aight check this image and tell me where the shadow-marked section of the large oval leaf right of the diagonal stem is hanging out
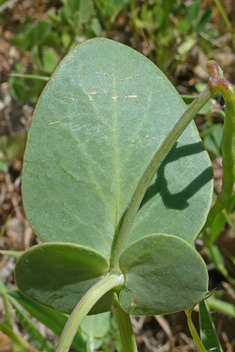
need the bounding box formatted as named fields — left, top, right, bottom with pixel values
left=127, top=140, right=213, bottom=244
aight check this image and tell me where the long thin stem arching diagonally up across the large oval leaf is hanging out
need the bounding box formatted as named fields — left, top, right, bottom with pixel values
left=110, top=86, right=213, bottom=272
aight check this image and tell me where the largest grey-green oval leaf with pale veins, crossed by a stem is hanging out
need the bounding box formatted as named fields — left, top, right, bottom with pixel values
left=23, top=39, right=212, bottom=258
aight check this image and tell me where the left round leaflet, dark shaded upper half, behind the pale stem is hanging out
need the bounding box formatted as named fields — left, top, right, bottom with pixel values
left=15, top=243, right=112, bottom=313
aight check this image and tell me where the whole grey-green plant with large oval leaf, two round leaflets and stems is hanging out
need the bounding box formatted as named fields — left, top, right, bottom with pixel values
left=16, top=39, right=235, bottom=352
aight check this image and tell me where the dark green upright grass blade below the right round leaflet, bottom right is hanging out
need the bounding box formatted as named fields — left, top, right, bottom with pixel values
left=199, top=301, right=223, bottom=352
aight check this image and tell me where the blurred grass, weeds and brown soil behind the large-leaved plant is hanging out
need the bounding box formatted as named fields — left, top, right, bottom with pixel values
left=0, top=0, right=235, bottom=352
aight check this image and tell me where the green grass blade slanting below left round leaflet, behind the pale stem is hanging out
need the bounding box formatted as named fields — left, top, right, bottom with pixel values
left=7, top=290, right=85, bottom=351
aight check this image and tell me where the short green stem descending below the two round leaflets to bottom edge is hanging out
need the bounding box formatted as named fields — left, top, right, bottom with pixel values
left=115, top=306, right=138, bottom=352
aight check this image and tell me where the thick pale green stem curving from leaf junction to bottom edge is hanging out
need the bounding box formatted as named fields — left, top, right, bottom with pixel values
left=55, top=275, right=124, bottom=352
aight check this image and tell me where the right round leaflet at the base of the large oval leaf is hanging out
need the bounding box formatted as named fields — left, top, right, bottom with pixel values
left=119, top=234, right=208, bottom=315
